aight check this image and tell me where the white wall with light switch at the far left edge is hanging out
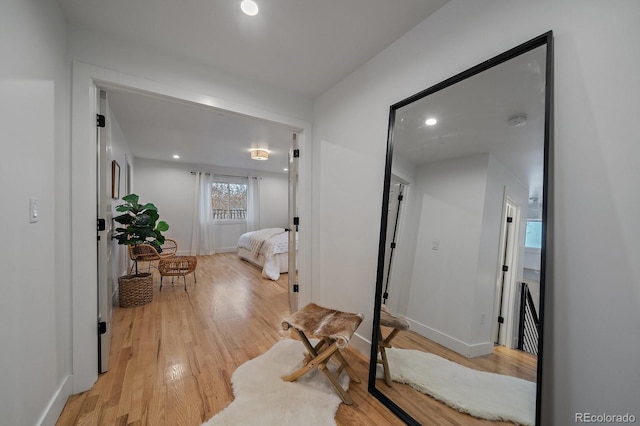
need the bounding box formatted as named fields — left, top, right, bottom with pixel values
left=0, top=0, right=71, bottom=425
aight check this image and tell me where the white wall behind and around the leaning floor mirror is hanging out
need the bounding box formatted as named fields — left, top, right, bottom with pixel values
left=313, top=0, right=640, bottom=425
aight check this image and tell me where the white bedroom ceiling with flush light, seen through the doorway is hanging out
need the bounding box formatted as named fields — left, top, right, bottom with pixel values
left=107, top=89, right=293, bottom=173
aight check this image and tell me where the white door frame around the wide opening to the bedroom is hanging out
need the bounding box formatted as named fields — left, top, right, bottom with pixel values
left=69, top=61, right=312, bottom=394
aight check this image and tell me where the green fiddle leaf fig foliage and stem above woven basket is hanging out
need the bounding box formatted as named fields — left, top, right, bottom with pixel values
left=113, top=194, right=169, bottom=275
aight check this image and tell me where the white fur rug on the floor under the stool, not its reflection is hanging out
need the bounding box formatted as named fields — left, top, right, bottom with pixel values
left=203, top=339, right=349, bottom=426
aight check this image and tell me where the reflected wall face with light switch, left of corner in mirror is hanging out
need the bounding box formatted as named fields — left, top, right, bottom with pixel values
left=400, top=155, right=489, bottom=356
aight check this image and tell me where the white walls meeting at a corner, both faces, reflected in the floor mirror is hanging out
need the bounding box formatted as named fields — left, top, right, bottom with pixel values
left=389, top=154, right=528, bottom=357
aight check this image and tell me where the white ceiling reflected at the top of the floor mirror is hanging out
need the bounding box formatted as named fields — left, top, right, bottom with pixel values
left=394, top=46, right=546, bottom=205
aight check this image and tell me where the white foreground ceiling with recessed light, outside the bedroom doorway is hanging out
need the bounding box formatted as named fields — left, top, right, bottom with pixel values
left=58, top=0, right=447, bottom=98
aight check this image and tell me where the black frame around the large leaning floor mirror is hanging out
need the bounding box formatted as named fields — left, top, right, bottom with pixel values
left=368, top=31, right=553, bottom=426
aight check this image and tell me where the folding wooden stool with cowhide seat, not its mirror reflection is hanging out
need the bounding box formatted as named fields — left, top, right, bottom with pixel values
left=282, top=303, right=364, bottom=405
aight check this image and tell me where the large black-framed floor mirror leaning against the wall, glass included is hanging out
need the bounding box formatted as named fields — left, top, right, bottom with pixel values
left=369, top=32, right=553, bottom=425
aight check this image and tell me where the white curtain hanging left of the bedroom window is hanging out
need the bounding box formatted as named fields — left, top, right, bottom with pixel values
left=191, top=172, right=215, bottom=256
